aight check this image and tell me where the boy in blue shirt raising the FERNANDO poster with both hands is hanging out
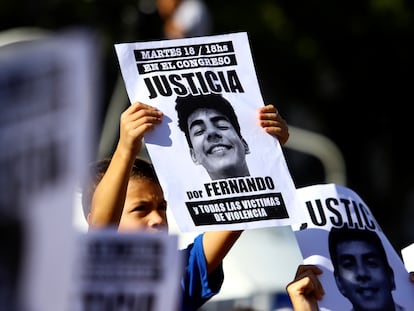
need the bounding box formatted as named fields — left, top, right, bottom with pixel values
left=82, top=103, right=289, bottom=310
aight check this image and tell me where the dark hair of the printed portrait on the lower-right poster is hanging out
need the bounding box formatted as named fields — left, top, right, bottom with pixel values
left=328, top=226, right=392, bottom=271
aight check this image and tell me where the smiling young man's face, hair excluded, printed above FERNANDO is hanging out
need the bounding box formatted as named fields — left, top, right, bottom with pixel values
left=187, top=108, right=249, bottom=179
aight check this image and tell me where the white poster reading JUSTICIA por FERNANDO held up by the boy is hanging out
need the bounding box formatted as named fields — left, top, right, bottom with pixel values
left=115, top=32, right=302, bottom=232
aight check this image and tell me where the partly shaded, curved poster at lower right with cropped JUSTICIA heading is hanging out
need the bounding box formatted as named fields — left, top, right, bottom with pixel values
left=292, top=184, right=414, bottom=311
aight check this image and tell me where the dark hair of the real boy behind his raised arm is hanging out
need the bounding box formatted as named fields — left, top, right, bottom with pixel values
left=82, top=157, right=159, bottom=219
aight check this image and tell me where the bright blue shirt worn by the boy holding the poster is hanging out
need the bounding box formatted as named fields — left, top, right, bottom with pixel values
left=180, top=234, right=224, bottom=311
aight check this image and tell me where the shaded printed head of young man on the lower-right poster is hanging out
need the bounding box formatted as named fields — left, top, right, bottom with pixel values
left=329, top=228, right=399, bottom=311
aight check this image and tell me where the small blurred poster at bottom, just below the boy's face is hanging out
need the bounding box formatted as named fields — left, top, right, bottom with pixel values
left=69, top=229, right=183, bottom=311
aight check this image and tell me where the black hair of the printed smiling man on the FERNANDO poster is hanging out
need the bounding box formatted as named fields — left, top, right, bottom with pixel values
left=175, top=93, right=243, bottom=148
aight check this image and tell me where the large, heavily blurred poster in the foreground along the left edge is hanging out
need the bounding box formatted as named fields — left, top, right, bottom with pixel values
left=0, top=30, right=97, bottom=311
